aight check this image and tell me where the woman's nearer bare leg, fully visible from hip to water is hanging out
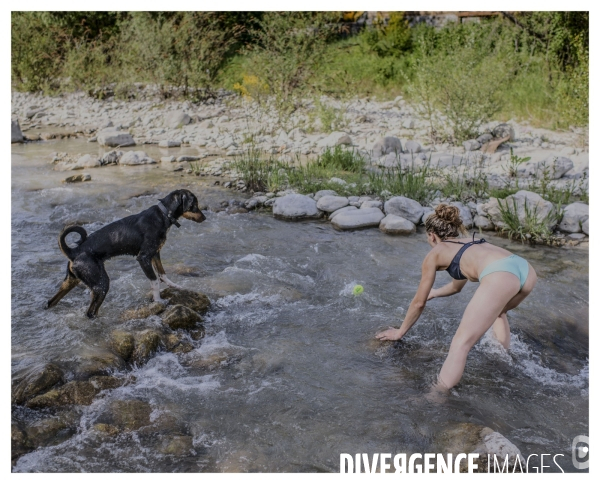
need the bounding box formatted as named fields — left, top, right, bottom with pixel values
left=438, top=272, right=520, bottom=389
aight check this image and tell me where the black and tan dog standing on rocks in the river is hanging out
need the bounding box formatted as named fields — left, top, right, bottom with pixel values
left=46, top=190, right=206, bottom=318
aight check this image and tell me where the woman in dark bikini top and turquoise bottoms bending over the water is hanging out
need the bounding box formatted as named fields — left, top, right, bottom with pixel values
left=376, top=204, right=537, bottom=390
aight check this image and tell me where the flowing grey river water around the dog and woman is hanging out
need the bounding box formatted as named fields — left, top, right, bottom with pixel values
left=11, top=140, right=588, bottom=472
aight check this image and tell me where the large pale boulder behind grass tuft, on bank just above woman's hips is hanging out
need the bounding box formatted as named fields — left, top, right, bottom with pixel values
left=481, top=190, right=557, bottom=230
